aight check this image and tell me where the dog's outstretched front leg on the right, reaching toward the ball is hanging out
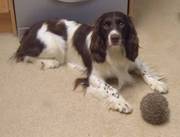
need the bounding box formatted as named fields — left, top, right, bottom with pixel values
left=135, top=59, right=168, bottom=93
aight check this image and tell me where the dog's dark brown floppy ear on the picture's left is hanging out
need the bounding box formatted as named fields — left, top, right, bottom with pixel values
left=90, top=16, right=106, bottom=63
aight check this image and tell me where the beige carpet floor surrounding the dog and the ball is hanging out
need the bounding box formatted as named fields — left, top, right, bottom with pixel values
left=0, top=0, right=180, bottom=137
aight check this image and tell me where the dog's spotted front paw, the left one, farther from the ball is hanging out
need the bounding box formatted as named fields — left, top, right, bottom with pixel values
left=110, top=96, right=133, bottom=114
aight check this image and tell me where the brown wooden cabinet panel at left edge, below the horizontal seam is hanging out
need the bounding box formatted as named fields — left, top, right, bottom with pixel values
left=0, top=13, right=12, bottom=32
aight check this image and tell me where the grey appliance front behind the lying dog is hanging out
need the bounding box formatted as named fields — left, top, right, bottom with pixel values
left=14, top=0, right=128, bottom=34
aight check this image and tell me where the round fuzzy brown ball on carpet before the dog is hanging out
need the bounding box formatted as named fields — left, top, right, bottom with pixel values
left=140, top=92, right=169, bottom=125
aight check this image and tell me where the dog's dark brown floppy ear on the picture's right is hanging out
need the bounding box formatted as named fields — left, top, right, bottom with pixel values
left=125, top=17, right=139, bottom=61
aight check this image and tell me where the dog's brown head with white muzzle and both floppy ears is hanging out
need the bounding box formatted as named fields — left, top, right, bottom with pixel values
left=90, top=12, right=139, bottom=63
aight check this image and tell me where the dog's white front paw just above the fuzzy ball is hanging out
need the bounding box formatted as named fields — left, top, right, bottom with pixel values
left=151, top=80, right=168, bottom=94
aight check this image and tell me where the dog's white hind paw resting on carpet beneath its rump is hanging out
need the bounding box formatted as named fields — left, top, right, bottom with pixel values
left=41, top=60, right=60, bottom=70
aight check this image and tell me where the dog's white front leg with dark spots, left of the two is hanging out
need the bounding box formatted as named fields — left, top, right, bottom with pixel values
left=87, top=75, right=132, bottom=114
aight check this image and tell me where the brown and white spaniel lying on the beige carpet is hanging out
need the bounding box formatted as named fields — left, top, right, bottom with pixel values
left=15, top=12, right=168, bottom=113
